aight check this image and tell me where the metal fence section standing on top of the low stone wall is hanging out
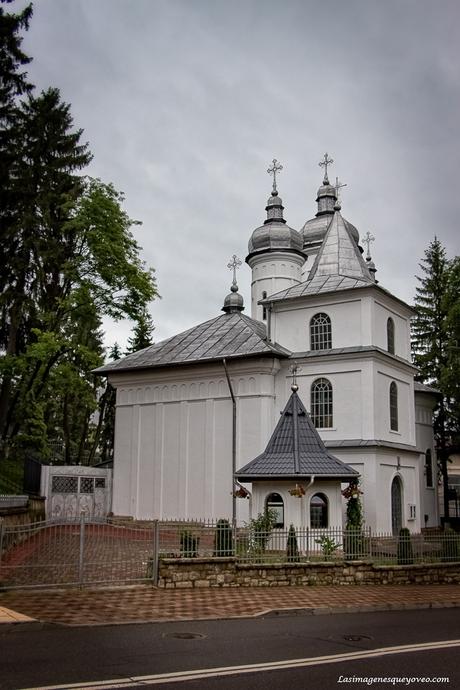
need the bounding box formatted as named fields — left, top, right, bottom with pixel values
left=158, top=521, right=460, bottom=565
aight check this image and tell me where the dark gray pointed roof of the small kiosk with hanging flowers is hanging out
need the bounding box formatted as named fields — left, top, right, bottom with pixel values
left=236, top=392, right=358, bottom=481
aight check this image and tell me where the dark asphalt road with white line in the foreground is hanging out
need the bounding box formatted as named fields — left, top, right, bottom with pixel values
left=0, top=609, right=460, bottom=690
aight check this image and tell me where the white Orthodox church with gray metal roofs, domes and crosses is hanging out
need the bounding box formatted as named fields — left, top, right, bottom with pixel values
left=96, top=154, right=439, bottom=533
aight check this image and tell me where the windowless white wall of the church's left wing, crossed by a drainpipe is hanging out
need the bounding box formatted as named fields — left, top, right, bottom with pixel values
left=111, top=358, right=278, bottom=520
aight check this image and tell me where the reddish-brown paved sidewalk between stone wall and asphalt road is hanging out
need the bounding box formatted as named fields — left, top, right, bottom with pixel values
left=0, top=585, right=460, bottom=625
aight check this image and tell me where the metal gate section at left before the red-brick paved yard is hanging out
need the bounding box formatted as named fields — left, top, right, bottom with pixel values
left=0, top=515, right=157, bottom=588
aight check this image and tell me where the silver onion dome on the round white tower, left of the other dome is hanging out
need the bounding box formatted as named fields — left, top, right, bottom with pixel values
left=246, top=190, right=303, bottom=261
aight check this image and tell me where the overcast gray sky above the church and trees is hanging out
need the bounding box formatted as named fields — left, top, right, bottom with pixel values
left=20, top=0, right=460, bottom=352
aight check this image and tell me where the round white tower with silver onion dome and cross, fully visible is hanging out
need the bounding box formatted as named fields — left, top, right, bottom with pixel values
left=246, top=158, right=305, bottom=323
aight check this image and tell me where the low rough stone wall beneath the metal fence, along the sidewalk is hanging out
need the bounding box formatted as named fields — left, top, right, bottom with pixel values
left=158, top=558, right=460, bottom=589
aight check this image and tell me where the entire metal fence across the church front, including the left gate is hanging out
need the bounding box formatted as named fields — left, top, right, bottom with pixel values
left=0, top=516, right=460, bottom=589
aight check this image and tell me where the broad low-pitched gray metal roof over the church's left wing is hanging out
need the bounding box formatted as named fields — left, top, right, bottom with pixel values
left=95, top=312, right=290, bottom=374
